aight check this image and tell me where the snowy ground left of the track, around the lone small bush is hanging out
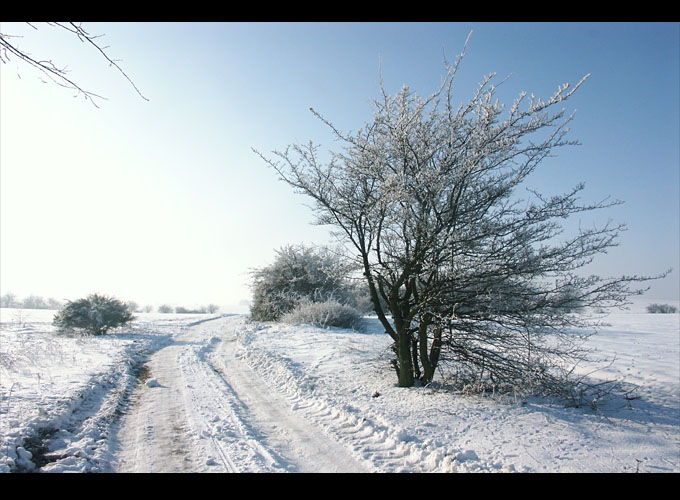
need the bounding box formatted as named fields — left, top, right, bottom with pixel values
left=0, top=309, right=209, bottom=472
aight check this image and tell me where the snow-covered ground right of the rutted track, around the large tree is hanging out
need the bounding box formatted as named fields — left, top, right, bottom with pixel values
left=231, top=308, right=680, bottom=472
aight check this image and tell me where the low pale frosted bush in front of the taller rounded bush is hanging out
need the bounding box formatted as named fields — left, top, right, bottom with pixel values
left=280, top=299, right=361, bottom=330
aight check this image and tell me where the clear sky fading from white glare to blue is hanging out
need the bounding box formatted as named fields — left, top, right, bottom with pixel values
left=0, top=23, right=680, bottom=306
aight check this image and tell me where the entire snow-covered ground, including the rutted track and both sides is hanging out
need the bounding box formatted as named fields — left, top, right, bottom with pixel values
left=0, top=301, right=680, bottom=472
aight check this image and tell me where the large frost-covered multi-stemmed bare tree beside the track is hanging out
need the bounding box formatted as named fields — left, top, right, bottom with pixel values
left=255, top=37, right=668, bottom=387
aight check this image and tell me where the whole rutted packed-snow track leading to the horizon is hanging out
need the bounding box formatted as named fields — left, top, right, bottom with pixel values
left=116, top=317, right=371, bottom=472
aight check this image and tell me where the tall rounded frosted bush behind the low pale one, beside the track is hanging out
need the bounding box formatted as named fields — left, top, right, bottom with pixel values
left=250, top=245, right=356, bottom=321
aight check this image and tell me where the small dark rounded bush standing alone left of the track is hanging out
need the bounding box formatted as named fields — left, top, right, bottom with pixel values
left=53, top=293, right=134, bottom=335
